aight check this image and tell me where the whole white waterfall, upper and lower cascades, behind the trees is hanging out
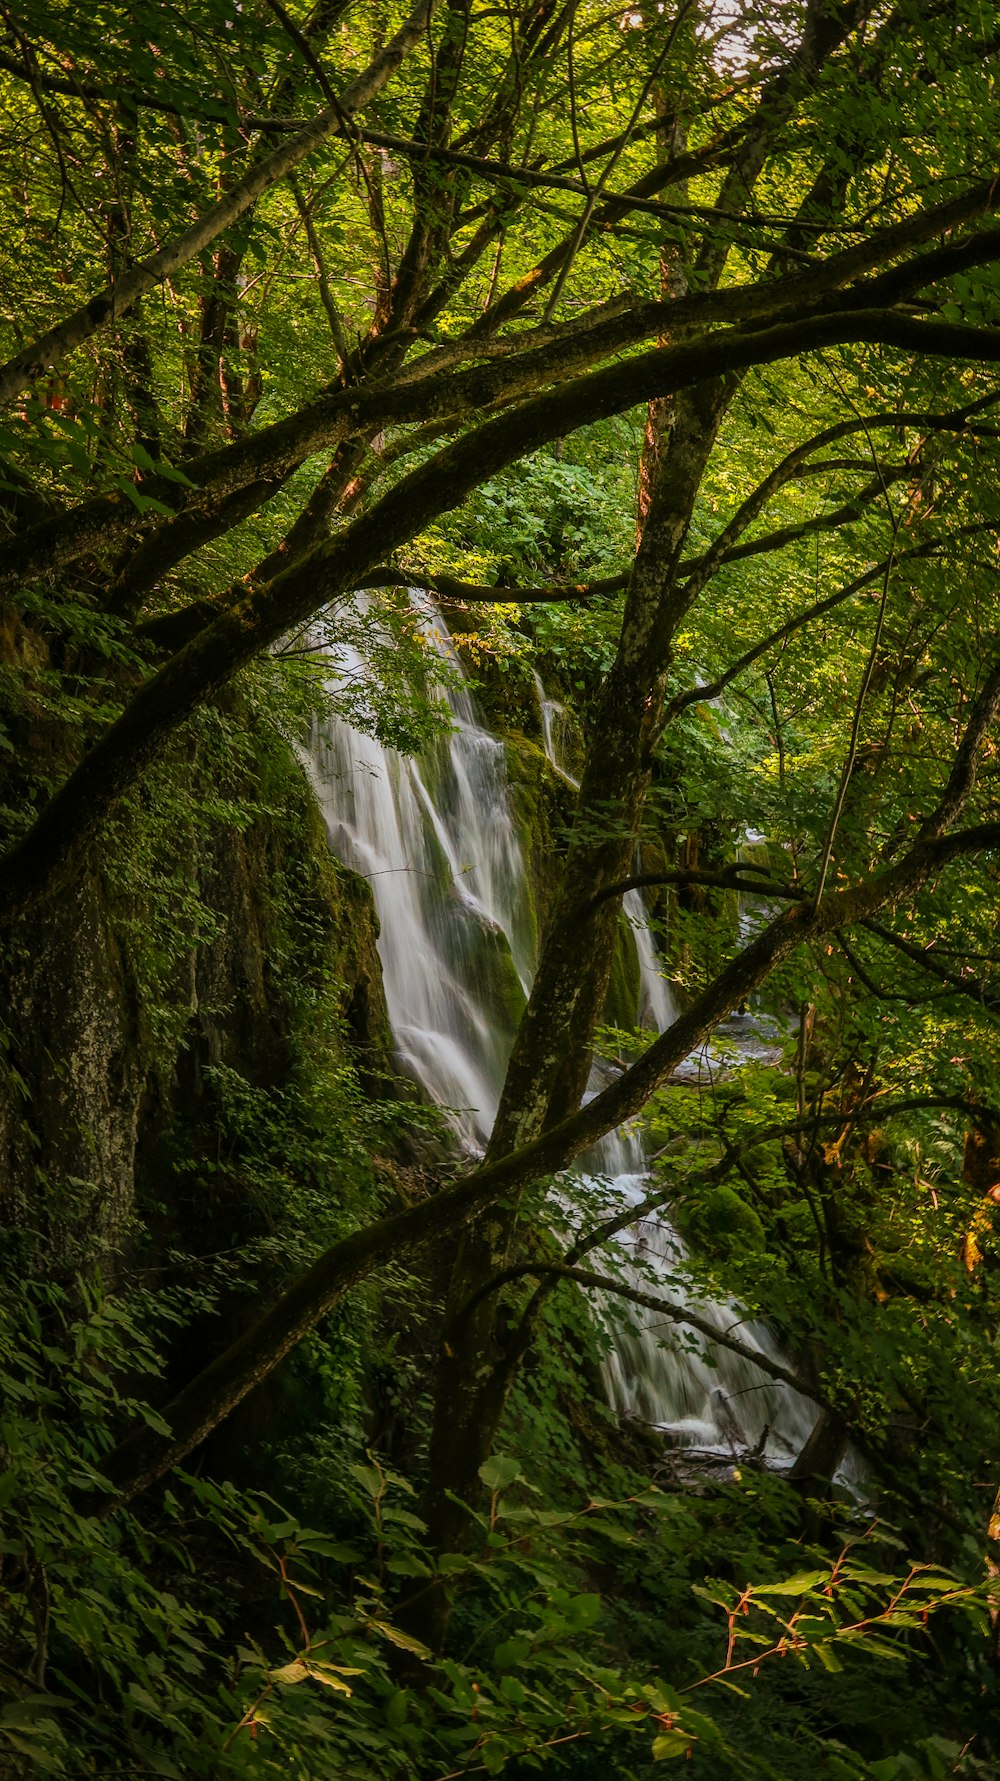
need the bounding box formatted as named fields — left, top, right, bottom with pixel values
left=308, top=616, right=815, bottom=1466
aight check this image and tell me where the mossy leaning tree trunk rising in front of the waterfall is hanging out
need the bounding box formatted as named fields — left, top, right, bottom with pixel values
left=408, top=379, right=733, bottom=1647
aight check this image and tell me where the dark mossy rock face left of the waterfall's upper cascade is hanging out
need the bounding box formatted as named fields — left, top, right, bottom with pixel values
left=0, top=715, right=389, bottom=1270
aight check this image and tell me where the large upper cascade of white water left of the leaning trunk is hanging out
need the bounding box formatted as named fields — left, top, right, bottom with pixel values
left=310, top=605, right=535, bottom=1149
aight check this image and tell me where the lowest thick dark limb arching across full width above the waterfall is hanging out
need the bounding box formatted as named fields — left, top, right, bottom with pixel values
left=0, top=310, right=1000, bottom=919
